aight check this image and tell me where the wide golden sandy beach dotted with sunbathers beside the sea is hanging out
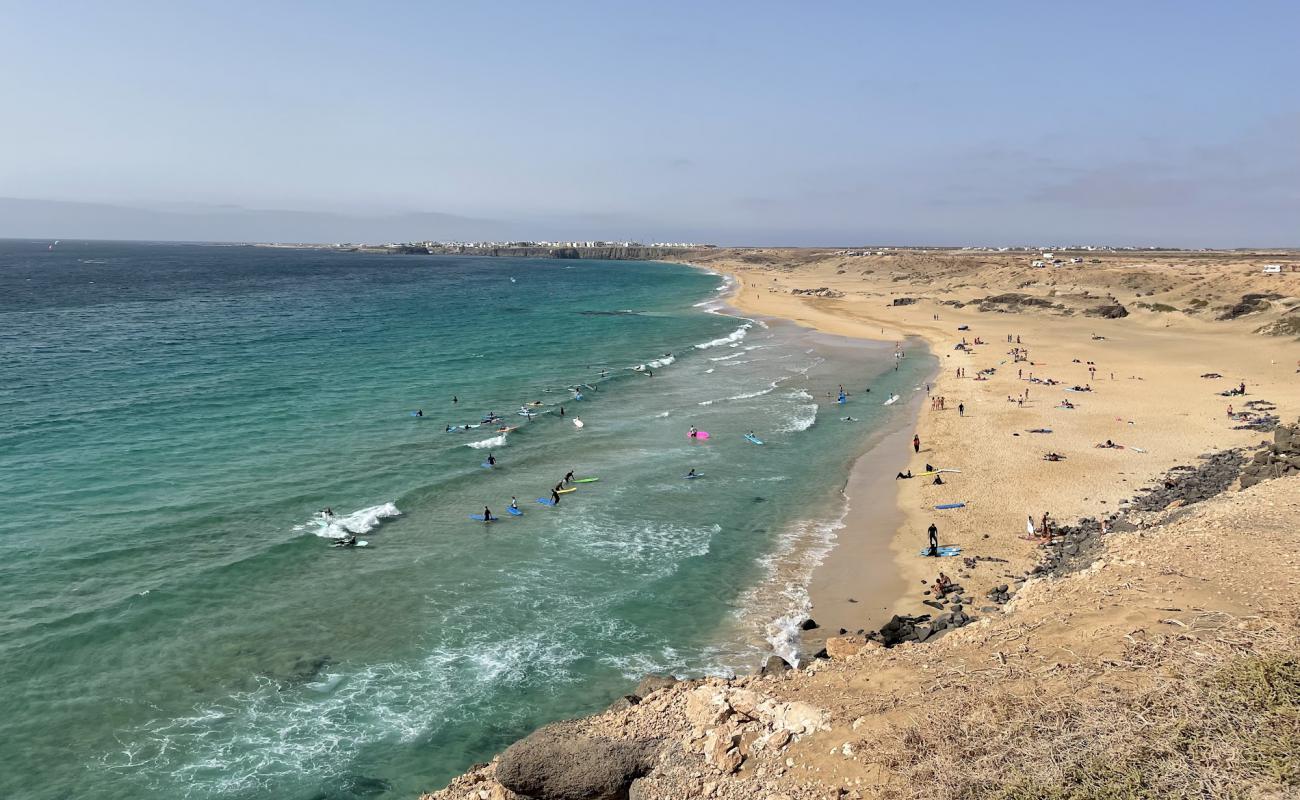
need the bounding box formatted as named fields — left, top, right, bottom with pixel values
left=706, top=251, right=1300, bottom=645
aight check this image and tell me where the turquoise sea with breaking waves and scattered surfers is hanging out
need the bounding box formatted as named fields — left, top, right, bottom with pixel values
left=0, top=242, right=926, bottom=800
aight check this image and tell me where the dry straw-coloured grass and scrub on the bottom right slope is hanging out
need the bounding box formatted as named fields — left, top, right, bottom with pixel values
left=876, top=618, right=1300, bottom=800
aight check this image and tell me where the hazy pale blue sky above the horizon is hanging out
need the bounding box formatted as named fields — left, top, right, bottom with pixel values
left=0, top=0, right=1300, bottom=247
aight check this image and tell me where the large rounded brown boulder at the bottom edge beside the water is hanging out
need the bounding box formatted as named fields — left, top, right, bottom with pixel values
left=497, top=725, right=655, bottom=800
